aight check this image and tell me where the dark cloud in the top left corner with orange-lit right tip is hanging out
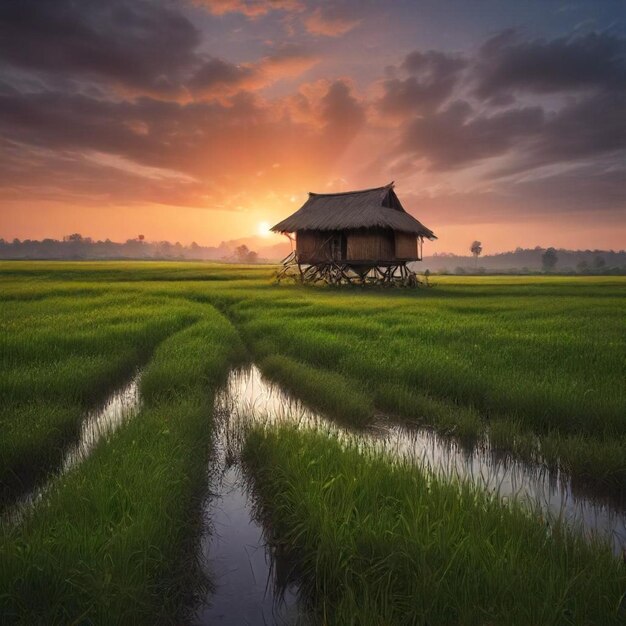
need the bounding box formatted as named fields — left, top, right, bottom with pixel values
left=0, top=0, right=318, bottom=100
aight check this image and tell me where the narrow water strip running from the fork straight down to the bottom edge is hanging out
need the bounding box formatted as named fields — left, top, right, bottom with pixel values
left=192, top=370, right=306, bottom=626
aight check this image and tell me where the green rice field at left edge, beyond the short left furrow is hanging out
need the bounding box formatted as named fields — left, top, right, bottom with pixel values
left=0, top=292, right=198, bottom=505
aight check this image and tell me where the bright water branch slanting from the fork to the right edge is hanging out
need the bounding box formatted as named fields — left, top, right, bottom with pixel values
left=216, top=366, right=626, bottom=553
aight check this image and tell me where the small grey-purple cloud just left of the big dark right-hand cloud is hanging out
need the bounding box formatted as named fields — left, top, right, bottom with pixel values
left=378, top=50, right=467, bottom=116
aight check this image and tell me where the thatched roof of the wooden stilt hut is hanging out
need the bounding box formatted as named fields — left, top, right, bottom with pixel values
left=272, top=182, right=437, bottom=239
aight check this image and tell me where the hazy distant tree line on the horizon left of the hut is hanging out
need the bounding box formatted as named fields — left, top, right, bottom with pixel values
left=0, top=233, right=260, bottom=263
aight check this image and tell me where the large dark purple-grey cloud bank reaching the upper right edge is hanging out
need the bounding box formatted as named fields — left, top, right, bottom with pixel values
left=392, top=31, right=626, bottom=176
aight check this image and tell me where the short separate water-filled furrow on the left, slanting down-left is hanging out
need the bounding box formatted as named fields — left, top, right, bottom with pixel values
left=5, top=371, right=141, bottom=523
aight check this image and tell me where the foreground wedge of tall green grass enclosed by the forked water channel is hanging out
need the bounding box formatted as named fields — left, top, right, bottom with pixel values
left=244, top=427, right=626, bottom=626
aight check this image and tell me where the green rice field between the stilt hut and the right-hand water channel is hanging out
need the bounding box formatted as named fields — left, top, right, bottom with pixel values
left=212, top=277, right=626, bottom=492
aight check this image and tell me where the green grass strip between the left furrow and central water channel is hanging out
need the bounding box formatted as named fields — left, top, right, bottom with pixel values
left=0, top=307, right=243, bottom=624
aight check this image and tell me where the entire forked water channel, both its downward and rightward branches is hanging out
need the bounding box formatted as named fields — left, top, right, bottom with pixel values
left=195, top=366, right=626, bottom=624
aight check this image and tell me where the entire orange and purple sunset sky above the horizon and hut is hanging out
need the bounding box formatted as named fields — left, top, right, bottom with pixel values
left=0, top=0, right=626, bottom=254
